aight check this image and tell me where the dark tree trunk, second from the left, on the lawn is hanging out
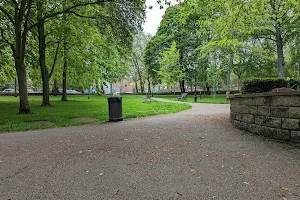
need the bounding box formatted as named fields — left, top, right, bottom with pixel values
left=37, top=18, right=50, bottom=106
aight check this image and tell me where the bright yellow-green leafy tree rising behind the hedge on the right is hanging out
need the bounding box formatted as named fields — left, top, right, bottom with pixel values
left=186, top=0, right=299, bottom=77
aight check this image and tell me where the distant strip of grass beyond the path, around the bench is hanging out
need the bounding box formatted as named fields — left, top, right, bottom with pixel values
left=154, top=94, right=230, bottom=104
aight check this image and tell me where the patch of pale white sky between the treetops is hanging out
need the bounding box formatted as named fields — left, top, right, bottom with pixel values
left=144, top=0, right=176, bottom=36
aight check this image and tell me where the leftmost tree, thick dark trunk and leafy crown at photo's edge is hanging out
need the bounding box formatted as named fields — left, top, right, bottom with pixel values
left=0, top=0, right=33, bottom=114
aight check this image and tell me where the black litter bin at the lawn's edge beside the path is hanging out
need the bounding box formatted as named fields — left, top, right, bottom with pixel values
left=107, top=97, right=123, bottom=122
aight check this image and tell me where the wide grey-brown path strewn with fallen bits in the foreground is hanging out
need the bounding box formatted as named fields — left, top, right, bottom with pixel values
left=0, top=104, right=300, bottom=200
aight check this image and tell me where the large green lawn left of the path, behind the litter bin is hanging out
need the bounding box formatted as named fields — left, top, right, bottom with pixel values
left=0, top=95, right=191, bottom=132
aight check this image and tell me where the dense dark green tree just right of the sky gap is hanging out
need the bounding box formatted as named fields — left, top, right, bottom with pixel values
left=145, top=4, right=202, bottom=92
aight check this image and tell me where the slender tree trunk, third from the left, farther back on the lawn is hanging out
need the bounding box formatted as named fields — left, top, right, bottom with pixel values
left=61, top=13, right=68, bottom=101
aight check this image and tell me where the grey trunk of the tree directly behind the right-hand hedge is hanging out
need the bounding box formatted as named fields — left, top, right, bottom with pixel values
left=275, top=23, right=284, bottom=78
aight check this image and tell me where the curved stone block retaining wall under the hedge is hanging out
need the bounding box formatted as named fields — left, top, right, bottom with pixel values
left=230, top=92, right=300, bottom=144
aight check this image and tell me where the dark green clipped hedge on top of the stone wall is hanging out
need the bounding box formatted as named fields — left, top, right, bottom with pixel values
left=242, top=78, right=300, bottom=94
